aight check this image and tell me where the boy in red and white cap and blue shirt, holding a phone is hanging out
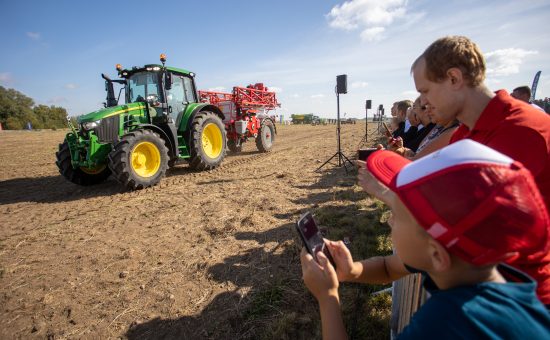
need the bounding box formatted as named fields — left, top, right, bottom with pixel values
left=301, top=140, right=550, bottom=339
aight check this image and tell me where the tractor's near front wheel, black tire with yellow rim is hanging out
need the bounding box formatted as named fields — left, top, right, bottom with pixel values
left=109, top=130, right=168, bottom=190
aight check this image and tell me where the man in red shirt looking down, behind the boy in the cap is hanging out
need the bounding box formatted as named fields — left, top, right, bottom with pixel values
left=359, top=36, right=550, bottom=306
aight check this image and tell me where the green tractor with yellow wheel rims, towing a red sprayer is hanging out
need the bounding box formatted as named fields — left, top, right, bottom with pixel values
left=56, top=54, right=227, bottom=190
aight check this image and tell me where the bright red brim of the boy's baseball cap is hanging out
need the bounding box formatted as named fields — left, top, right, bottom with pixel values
left=367, top=150, right=411, bottom=190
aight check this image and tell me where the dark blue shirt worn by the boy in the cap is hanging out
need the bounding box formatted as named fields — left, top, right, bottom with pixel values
left=398, top=264, right=550, bottom=339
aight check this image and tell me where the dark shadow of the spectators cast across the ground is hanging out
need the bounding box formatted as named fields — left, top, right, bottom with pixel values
left=126, top=168, right=390, bottom=339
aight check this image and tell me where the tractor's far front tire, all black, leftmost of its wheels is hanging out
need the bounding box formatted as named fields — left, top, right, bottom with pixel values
left=55, top=140, right=111, bottom=186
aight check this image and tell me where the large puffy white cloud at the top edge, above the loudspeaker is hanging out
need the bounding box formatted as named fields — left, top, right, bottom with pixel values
left=326, top=0, right=407, bottom=41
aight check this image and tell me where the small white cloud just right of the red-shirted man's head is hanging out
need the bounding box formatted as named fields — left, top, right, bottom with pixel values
left=485, top=48, right=538, bottom=77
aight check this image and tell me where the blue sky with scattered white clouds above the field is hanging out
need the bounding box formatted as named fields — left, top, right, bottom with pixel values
left=0, top=0, right=550, bottom=118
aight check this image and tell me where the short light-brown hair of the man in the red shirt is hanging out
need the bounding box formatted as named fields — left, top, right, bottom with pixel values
left=411, top=36, right=486, bottom=87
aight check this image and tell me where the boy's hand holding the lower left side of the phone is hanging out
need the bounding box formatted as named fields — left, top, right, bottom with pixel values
left=300, top=248, right=339, bottom=303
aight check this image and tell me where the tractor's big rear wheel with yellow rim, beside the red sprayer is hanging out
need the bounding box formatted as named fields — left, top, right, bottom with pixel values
left=189, top=111, right=227, bottom=170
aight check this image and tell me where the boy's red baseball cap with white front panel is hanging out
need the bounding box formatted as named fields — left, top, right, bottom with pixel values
left=367, top=139, right=550, bottom=265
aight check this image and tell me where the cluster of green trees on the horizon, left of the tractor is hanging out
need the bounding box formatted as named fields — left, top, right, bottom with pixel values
left=0, top=86, right=67, bottom=130
